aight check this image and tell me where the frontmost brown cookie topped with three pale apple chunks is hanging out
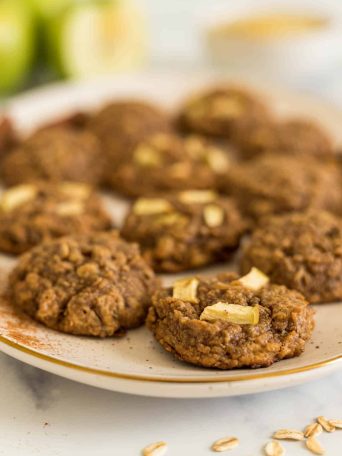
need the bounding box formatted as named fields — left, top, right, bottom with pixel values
left=147, top=271, right=314, bottom=369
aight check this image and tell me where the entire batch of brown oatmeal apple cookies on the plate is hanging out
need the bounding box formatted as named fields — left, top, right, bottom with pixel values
left=0, top=86, right=342, bottom=369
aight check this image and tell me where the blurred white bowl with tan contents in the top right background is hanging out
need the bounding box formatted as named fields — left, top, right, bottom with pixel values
left=202, top=0, right=342, bottom=81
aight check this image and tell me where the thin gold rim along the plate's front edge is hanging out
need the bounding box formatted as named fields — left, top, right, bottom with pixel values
left=0, top=335, right=342, bottom=384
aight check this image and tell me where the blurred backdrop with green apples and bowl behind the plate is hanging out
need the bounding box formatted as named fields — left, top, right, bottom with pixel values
left=0, top=0, right=342, bottom=102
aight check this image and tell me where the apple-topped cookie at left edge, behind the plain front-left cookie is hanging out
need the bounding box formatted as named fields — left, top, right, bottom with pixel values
left=0, top=182, right=112, bottom=255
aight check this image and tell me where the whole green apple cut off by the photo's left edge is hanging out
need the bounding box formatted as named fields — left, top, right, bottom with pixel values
left=0, top=0, right=34, bottom=93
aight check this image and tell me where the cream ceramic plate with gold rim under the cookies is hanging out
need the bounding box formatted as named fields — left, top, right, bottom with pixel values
left=0, top=69, right=342, bottom=397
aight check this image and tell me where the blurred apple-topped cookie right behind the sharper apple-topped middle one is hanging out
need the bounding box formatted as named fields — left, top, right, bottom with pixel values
left=110, top=133, right=231, bottom=197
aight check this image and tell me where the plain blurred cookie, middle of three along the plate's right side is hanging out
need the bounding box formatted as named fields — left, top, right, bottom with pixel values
left=223, top=154, right=341, bottom=220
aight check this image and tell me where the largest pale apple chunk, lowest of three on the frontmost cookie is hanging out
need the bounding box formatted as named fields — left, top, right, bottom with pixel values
left=200, top=302, right=259, bottom=325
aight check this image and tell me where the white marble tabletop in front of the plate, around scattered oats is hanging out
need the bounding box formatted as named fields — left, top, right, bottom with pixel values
left=0, top=354, right=342, bottom=456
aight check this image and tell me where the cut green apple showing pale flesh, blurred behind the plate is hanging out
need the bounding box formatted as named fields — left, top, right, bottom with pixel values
left=48, top=0, right=146, bottom=78
